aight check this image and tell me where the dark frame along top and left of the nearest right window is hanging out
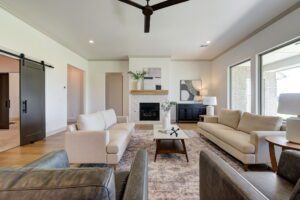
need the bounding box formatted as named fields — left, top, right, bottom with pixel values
left=257, top=37, right=300, bottom=115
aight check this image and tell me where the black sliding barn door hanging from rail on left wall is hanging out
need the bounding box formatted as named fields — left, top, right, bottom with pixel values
left=20, top=59, right=45, bottom=145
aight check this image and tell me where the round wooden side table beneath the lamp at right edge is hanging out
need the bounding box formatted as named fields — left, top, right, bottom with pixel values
left=266, top=136, right=300, bottom=172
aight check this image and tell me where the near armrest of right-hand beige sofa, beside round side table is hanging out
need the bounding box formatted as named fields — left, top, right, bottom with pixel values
left=250, top=131, right=286, bottom=163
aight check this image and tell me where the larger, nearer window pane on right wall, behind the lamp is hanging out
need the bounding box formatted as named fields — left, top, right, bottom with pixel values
left=260, top=41, right=300, bottom=118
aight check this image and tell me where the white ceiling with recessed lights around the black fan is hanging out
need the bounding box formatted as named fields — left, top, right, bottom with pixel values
left=0, top=0, right=299, bottom=60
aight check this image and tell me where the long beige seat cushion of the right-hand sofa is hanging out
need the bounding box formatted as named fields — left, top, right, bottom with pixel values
left=198, top=122, right=255, bottom=154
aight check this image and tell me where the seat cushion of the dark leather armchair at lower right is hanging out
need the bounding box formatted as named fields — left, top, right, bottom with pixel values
left=242, top=172, right=293, bottom=200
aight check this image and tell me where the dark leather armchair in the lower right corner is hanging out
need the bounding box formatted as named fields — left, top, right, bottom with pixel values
left=199, top=150, right=300, bottom=200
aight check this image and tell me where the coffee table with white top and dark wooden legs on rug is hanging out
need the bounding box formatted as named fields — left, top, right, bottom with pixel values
left=153, top=125, right=189, bottom=162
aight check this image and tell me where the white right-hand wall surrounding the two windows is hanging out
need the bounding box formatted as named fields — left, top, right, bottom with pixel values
left=212, top=8, right=300, bottom=113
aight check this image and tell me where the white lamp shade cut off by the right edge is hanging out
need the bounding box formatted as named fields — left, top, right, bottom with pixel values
left=277, top=93, right=300, bottom=115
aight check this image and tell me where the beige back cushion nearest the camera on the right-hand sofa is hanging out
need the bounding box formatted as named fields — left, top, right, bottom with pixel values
left=238, top=112, right=282, bottom=134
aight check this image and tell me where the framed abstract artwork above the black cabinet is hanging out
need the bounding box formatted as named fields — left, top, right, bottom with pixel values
left=180, top=80, right=202, bottom=101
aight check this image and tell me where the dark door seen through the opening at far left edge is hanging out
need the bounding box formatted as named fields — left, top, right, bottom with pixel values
left=0, top=73, right=9, bottom=129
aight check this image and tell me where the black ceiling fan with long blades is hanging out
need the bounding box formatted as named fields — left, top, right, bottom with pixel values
left=119, top=0, right=189, bottom=33
